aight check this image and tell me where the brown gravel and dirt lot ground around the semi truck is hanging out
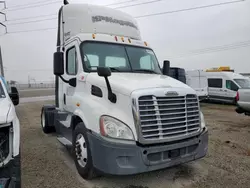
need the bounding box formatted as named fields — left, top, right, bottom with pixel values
left=17, top=101, right=250, bottom=188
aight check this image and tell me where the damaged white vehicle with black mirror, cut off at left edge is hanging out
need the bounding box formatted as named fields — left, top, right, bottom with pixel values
left=0, top=76, right=21, bottom=188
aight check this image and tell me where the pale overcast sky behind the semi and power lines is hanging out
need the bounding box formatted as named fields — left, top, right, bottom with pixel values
left=0, top=0, right=250, bottom=83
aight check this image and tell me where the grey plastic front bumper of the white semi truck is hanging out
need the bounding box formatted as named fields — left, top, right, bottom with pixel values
left=88, top=129, right=208, bottom=175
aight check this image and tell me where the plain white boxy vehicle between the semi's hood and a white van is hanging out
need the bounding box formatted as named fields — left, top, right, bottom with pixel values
left=186, top=70, right=208, bottom=101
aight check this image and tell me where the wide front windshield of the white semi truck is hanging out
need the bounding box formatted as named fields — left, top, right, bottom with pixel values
left=81, top=42, right=161, bottom=74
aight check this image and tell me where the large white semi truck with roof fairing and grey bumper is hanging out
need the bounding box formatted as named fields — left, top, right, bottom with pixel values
left=41, top=1, right=208, bottom=179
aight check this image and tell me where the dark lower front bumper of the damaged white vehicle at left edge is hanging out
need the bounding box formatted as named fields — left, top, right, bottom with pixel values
left=0, top=155, right=21, bottom=188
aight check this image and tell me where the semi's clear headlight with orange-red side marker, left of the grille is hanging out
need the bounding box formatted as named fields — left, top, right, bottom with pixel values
left=100, top=116, right=134, bottom=140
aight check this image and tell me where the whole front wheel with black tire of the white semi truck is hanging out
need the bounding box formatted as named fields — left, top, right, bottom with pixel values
left=73, top=123, right=96, bottom=180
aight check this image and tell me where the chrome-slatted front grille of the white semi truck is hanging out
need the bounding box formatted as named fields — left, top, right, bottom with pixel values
left=138, top=95, right=200, bottom=140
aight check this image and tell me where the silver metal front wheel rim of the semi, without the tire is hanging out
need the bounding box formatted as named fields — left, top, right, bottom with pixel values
left=75, top=134, right=87, bottom=167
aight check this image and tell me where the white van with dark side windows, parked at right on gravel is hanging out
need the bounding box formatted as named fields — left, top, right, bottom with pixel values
left=206, top=72, right=250, bottom=104
